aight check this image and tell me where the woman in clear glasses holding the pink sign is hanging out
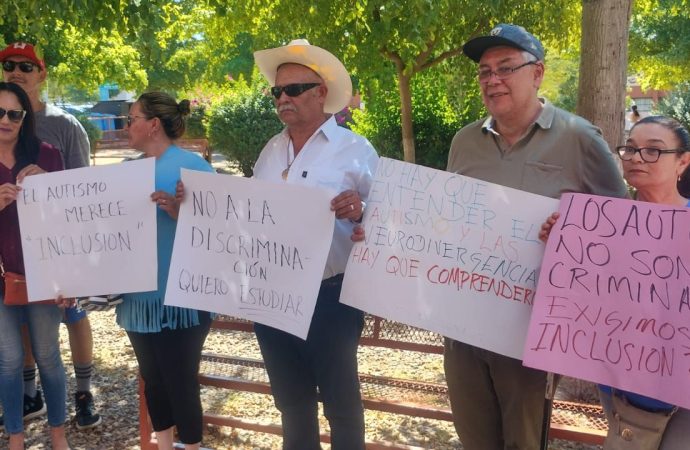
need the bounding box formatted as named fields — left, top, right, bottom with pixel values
left=539, top=116, right=690, bottom=450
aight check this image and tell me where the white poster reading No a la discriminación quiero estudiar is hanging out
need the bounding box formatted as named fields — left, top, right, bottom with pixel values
left=165, top=170, right=335, bottom=339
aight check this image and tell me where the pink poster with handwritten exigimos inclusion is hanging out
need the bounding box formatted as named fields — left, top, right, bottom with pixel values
left=524, top=194, right=690, bottom=408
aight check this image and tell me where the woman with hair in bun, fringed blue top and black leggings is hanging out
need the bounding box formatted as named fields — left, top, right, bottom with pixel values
left=116, top=92, right=213, bottom=449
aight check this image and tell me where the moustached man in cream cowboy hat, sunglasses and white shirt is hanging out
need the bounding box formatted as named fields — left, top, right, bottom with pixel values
left=254, top=39, right=378, bottom=450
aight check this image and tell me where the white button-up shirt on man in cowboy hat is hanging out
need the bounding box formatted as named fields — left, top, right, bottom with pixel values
left=254, top=116, right=378, bottom=280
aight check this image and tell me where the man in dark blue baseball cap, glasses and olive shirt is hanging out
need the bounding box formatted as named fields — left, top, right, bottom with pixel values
left=444, top=24, right=626, bottom=450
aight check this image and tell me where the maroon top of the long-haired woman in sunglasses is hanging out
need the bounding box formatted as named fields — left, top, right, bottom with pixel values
left=0, top=142, right=62, bottom=290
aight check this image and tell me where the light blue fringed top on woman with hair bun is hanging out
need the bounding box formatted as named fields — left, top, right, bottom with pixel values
left=116, top=145, right=213, bottom=333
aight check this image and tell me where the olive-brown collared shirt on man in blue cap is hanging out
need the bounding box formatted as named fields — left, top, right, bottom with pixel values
left=446, top=100, right=627, bottom=198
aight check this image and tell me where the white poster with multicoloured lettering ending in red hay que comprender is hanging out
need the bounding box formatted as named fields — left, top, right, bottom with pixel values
left=340, top=158, right=558, bottom=358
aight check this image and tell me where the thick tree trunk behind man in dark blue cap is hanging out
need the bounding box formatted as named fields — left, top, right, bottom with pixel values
left=577, top=0, right=633, bottom=149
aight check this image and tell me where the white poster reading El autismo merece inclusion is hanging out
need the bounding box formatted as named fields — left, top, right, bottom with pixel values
left=17, top=158, right=157, bottom=301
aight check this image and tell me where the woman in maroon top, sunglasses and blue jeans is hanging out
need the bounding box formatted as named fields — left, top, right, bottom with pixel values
left=0, top=82, right=69, bottom=450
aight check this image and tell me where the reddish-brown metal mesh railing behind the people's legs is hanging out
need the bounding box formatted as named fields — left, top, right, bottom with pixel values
left=139, top=315, right=607, bottom=450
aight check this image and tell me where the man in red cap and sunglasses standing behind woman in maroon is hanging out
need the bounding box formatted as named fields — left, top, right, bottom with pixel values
left=0, top=42, right=101, bottom=429
